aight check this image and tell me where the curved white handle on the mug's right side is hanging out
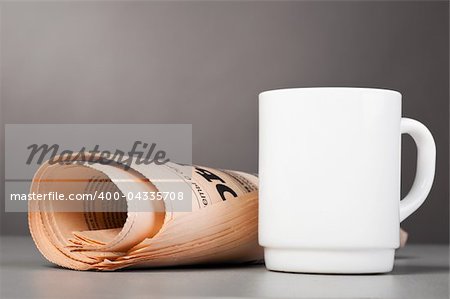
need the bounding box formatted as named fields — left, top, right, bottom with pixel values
left=400, top=118, right=436, bottom=222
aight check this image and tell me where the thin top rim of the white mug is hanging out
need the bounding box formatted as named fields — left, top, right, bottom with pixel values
left=259, top=86, right=402, bottom=98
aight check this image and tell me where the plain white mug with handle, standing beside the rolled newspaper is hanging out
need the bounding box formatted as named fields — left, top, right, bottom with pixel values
left=259, top=87, right=436, bottom=273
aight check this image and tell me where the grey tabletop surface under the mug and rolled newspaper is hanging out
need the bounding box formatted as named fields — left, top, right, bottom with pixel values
left=0, top=237, right=449, bottom=298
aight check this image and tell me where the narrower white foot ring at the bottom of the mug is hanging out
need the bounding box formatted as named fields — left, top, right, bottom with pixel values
left=264, top=247, right=395, bottom=274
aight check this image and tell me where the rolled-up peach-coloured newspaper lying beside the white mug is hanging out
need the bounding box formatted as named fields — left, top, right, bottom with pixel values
left=28, top=156, right=263, bottom=270
